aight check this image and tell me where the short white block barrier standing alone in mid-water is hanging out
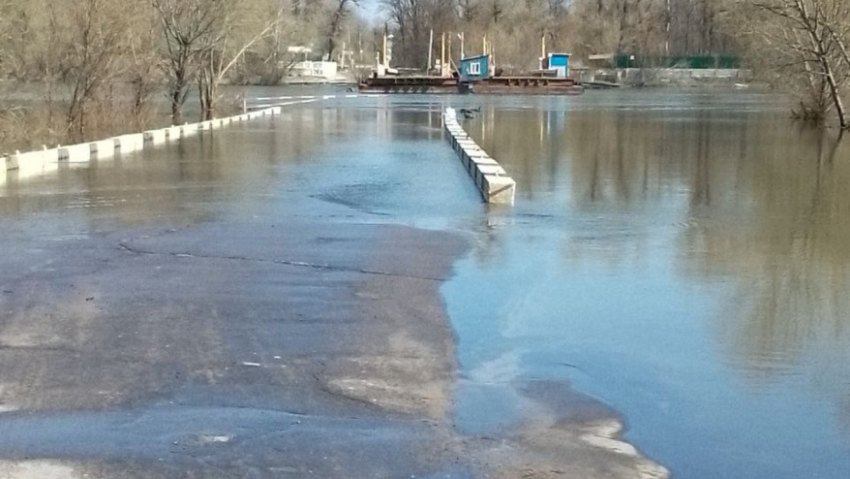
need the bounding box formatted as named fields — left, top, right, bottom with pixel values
left=443, top=108, right=516, bottom=205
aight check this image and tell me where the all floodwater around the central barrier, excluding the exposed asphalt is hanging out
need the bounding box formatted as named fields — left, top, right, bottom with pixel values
left=0, top=91, right=850, bottom=479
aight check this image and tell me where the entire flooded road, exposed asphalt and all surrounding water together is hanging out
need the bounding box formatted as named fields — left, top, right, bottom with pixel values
left=0, top=91, right=850, bottom=479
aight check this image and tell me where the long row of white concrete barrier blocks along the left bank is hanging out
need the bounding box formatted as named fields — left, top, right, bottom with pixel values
left=0, top=100, right=292, bottom=186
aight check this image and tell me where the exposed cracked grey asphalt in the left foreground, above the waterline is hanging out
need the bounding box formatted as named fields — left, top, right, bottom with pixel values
left=0, top=219, right=465, bottom=477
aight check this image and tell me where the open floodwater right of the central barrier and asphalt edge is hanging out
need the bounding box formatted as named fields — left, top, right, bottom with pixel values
left=445, top=92, right=850, bottom=479
